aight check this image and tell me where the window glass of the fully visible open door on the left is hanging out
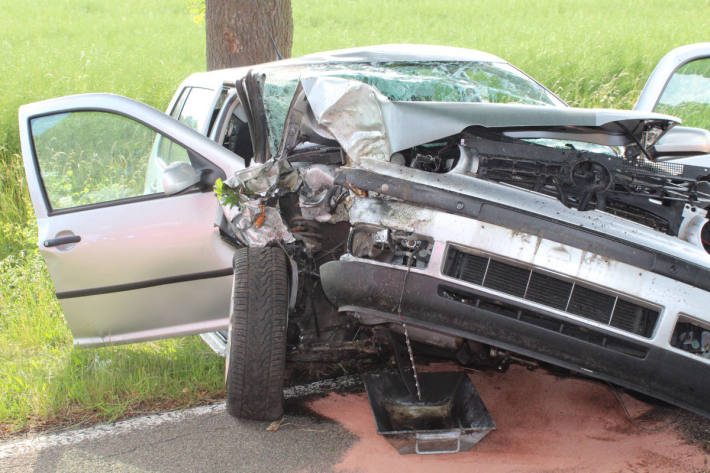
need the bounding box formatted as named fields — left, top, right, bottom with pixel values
left=30, top=111, right=192, bottom=210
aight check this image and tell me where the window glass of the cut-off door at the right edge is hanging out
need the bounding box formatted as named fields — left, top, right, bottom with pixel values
left=654, top=58, right=710, bottom=129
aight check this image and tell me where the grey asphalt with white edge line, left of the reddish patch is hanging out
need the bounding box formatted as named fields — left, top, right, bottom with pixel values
left=0, top=380, right=356, bottom=473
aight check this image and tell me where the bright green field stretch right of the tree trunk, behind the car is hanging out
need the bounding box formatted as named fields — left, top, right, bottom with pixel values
left=294, top=0, right=710, bottom=107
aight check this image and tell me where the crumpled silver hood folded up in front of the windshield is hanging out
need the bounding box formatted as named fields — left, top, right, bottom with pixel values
left=301, top=77, right=680, bottom=162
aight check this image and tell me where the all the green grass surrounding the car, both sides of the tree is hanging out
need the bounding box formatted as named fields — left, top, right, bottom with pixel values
left=0, top=0, right=710, bottom=434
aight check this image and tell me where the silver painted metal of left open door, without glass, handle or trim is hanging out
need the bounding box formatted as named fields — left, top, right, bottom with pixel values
left=20, top=94, right=244, bottom=345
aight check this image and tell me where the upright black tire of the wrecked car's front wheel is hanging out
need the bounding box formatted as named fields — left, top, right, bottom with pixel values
left=225, top=248, right=288, bottom=420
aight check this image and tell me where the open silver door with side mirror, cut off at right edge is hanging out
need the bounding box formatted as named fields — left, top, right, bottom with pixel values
left=634, top=43, right=710, bottom=167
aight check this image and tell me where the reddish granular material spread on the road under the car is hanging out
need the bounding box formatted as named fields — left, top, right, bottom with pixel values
left=310, top=366, right=710, bottom=473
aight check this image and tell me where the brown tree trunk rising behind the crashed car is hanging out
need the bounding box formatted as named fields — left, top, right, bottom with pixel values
left=205, top=0, right=293, bottom=71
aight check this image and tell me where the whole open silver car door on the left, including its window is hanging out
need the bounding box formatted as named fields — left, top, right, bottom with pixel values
left=19, top=94, right=244, bottom=345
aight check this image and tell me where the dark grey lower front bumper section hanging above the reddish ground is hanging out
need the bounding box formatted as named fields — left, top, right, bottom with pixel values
left=320, top=259, right=710, bottom=417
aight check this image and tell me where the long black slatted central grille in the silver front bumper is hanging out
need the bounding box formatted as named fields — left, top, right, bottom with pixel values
left=444, top=248, right=659, bottom=338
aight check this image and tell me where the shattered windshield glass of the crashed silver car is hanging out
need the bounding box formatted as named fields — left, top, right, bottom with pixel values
left=264, top=61, right=563, bottom=153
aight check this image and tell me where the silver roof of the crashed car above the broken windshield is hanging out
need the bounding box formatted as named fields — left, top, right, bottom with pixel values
left=181, top=44, right=506, bottom=89
